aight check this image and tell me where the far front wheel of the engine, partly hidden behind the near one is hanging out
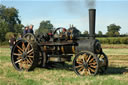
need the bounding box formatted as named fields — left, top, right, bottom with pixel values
left=97, top=53, right=108, bottom=74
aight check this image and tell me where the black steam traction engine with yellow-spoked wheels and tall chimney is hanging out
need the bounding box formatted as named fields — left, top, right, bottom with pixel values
left=11, top=9, right=108, bottom=75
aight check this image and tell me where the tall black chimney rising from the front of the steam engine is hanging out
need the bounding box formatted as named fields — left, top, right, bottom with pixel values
left=89, top=9, right=96, bottom=39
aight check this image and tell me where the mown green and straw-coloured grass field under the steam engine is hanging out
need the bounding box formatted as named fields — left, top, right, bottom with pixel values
left=0, top=45, right=128, bottom=85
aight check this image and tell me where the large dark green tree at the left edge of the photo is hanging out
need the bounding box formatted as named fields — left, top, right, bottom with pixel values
left=0, top=4, right=23, bottom=42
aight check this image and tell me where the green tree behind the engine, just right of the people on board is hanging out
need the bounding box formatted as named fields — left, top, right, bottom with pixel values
left=35, top=20, right=53, bottom=34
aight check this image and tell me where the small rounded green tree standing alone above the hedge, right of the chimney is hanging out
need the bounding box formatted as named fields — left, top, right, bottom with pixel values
left=107, top=24, right=121, bottom=37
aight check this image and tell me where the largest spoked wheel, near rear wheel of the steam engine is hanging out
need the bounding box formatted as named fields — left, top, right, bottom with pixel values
left=11, top=40, right=39, bottom=71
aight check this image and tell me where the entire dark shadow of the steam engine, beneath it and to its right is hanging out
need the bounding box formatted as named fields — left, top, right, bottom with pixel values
left=39, top=63, right=128, bottom=75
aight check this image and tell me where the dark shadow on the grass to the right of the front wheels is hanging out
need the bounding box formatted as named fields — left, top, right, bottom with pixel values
left=106, top=67, right=128, bottom=75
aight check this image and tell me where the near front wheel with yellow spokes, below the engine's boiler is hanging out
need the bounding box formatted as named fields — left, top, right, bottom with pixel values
left=73, top=51, right=99, bottom=76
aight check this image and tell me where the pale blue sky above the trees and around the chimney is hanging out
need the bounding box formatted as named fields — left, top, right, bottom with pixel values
left=0, top=0, right=128, bottom=33
